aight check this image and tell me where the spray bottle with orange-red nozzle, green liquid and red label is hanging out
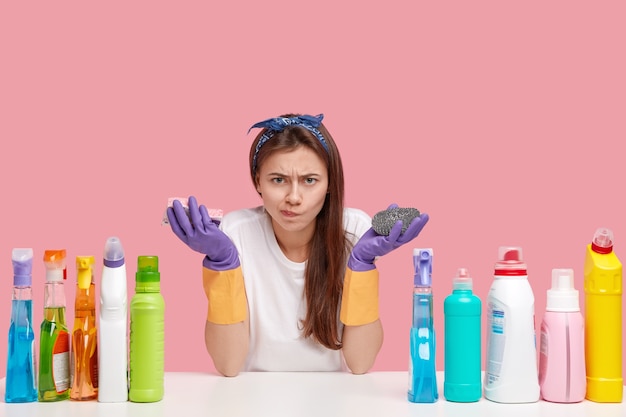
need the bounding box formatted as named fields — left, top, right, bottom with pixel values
left=39, top=249, right=70, bottom=402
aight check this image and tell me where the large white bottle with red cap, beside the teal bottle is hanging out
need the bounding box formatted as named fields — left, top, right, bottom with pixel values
left=485, top=246, right=540, bottom=403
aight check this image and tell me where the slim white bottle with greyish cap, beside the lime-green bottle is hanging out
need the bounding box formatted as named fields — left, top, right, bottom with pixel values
left=98, top=236, right=128, bottom=402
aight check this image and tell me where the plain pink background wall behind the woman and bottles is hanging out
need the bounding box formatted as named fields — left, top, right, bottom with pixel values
left=0, top=0, right=626, bottom=375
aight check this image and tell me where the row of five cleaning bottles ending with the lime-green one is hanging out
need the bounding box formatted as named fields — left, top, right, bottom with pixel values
left=5, top=237, right=164, bottom=402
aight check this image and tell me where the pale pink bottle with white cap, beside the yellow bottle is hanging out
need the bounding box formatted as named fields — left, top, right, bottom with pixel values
left=539, top=268, right=587, bottom=403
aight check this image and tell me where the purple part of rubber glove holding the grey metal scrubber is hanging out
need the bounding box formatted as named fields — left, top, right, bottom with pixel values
left=348, top=204, right=428, bottom=272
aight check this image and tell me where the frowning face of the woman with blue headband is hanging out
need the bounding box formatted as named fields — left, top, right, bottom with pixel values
left=257, top=146, right=328, bottom=237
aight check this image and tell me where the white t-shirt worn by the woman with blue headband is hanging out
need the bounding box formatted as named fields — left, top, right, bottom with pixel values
left=220, top=207, right=372, bottom=371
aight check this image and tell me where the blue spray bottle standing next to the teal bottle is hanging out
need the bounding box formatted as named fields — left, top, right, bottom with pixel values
left=408, top=248, right=439, bottom=403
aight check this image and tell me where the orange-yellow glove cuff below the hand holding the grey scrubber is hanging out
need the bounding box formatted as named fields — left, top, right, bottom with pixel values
left=339, top=268, right=379, bottom=326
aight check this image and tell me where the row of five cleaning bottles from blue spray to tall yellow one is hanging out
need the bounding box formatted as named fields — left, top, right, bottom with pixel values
left=409, top=224, right=623, bottom=403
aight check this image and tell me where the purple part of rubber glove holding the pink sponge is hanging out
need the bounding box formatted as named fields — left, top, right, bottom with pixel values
left=167, top=196, right=239, bottom=271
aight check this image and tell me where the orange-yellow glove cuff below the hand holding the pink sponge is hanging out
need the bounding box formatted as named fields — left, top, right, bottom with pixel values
left=202, top=266, right=248, bottom=324
